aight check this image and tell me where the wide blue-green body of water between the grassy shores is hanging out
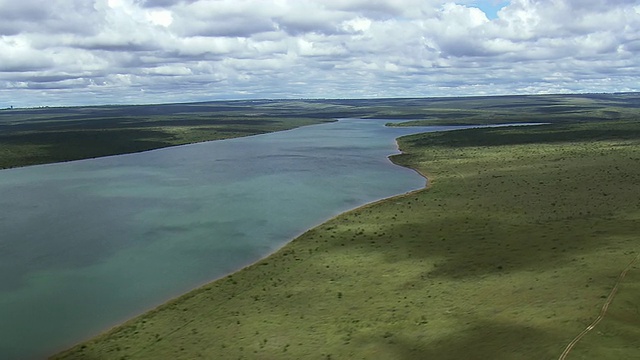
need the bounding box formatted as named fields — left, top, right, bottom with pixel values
left=0, top=119, right=470, bottom=359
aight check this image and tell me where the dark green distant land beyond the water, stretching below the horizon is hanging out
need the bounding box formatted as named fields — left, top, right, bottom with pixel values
left=0, top=93, right=637, bottom=169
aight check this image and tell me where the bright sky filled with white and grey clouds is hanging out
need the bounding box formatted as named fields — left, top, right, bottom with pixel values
left=0, top=0, right=640, bottom=108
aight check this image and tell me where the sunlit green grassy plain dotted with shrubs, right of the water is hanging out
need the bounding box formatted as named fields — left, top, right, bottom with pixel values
left=54, top=96, right=640, bottom=360
